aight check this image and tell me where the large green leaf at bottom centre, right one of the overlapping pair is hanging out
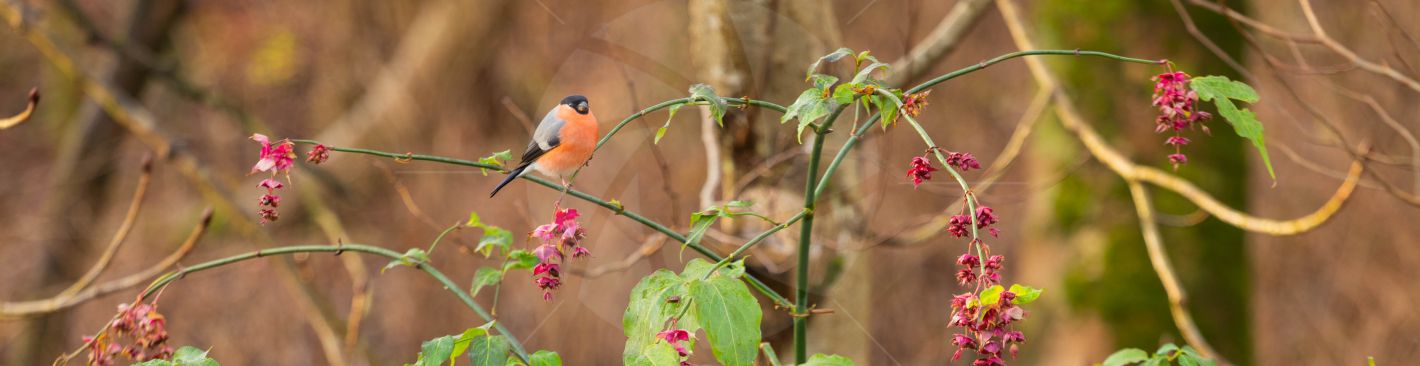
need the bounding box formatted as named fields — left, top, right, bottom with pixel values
left=690, top=270, right=763, bottom=366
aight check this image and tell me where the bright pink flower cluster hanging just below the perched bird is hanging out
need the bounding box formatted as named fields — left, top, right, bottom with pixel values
left=531, top=209, right=591, bottom=301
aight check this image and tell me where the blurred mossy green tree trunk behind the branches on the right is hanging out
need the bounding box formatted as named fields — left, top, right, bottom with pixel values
left=1037, top=1, right=1267, bottom=365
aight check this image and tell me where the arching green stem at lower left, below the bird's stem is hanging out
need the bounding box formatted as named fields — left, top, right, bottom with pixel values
left=139, top=244, right=528, bottom=363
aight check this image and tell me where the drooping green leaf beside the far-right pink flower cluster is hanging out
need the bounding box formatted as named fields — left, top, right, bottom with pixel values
left=1189, top=77, right=1277, bottom=180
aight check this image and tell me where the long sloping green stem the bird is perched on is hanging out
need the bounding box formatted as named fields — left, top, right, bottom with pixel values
left=291, top=139, right=794, bottom=308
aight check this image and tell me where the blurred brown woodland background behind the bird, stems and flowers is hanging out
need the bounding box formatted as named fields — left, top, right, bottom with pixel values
left=0, top=0, right=1420, bottom=365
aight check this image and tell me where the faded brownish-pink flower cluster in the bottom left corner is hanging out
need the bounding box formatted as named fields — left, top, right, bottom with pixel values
left=84, top=304, right=173, bottom=366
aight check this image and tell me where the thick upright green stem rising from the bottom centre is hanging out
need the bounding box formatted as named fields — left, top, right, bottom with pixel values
left=794, top=105, right=846, bottom=365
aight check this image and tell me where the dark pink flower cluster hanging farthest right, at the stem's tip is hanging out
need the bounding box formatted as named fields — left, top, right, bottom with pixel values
left=1153, top=71, right=1213, bottom=170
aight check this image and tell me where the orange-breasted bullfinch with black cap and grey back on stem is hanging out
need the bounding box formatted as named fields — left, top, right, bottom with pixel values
left=488, top=95, right=601, bottom=197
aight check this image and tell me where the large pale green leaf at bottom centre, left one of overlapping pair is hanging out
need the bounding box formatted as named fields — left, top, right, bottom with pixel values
left=622, top=268, right=703, bottom=365
